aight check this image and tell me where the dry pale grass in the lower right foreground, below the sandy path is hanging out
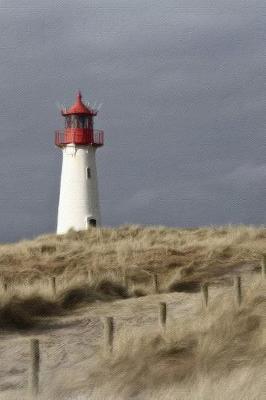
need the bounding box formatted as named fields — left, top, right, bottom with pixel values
left=50, top=282, right=266, bottom=400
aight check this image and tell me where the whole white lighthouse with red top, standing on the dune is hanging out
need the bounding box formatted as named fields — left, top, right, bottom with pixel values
left=55, top=92, right=104, bottom=234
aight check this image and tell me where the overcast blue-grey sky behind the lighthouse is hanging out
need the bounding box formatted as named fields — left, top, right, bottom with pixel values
left=0, top=0, right=266, bottom=242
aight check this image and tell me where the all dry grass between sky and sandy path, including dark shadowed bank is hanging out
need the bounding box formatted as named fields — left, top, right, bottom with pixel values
left=0, top=226, right=266, bottom=329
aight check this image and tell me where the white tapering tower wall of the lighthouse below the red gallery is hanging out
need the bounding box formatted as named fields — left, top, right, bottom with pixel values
left=57, top=144, right=101, bottom=234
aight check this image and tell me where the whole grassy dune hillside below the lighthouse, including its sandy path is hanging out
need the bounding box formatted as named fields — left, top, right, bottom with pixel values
left=0, top=226, right=266, bottom=400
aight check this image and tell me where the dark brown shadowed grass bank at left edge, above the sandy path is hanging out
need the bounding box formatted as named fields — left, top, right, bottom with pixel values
left=0, top=280, right=130, bottom=331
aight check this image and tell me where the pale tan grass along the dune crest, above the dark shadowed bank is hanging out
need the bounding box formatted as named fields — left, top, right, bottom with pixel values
left=0, top=225, right=266, bottom=290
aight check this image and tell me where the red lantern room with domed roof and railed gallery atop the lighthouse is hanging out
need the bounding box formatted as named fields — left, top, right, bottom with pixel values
left=55, top=92, right=104, bottom=147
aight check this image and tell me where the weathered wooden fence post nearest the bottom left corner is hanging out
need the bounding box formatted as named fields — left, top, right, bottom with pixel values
left=29, top=339, right=40, bottom=399
